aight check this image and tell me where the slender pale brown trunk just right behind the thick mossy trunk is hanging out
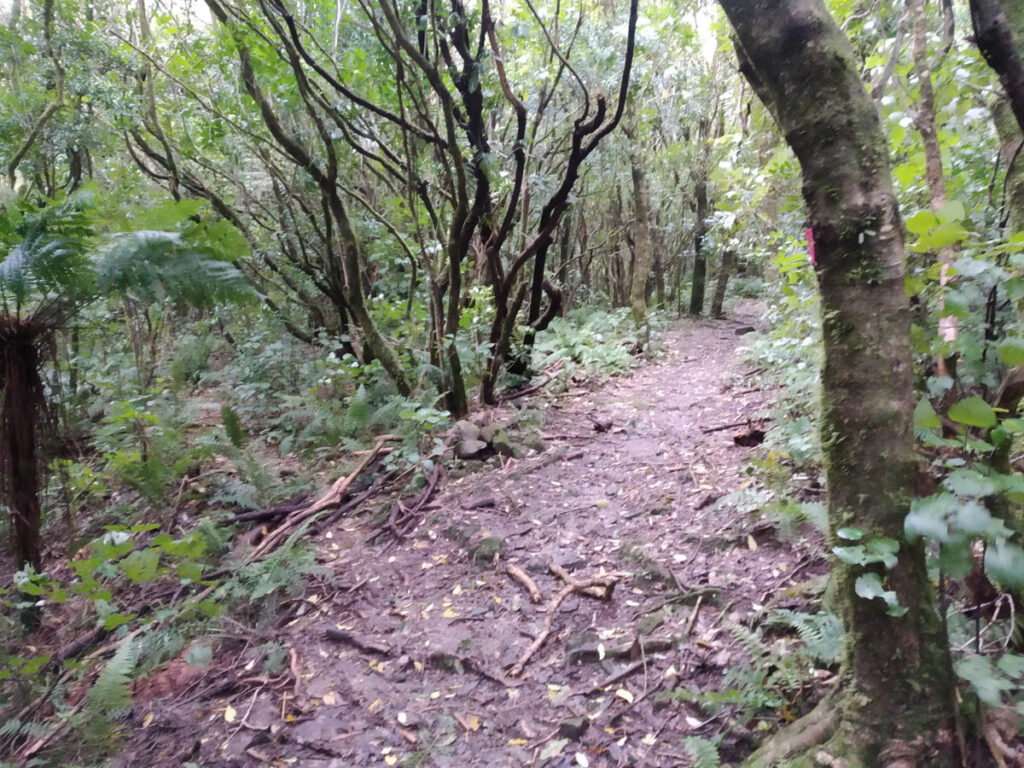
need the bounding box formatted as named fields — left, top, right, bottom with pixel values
left=906, top=0, right=959, bottom=376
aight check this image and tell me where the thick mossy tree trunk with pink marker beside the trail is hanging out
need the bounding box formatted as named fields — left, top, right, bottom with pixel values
left=721, top=0, right=953, bottom=768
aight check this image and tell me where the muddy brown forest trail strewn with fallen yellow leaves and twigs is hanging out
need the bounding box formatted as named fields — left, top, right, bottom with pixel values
left=134, top=308, right=823, bottom=768
